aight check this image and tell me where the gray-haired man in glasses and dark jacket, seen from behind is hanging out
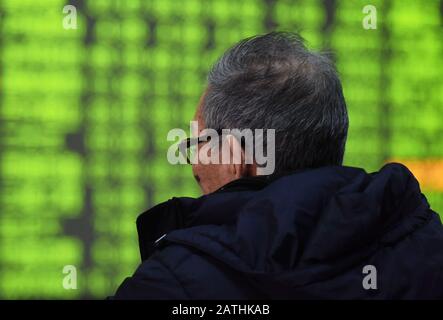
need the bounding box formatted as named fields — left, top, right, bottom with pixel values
left=113, top=33, right=443, bottom=299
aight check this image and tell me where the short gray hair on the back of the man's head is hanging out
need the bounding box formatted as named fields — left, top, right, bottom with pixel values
left=202, top=32, right=349, bottom=172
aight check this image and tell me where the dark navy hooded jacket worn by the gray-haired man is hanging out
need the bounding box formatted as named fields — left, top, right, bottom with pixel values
left=113, top=164, right=443, bottom=299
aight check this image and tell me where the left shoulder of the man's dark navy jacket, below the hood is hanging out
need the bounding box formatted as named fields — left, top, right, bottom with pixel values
left=112, top=244, right=256, bottom=300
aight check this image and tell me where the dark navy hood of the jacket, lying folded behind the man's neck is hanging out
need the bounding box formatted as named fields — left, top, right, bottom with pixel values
left=137, top=164, right=432, bottom=297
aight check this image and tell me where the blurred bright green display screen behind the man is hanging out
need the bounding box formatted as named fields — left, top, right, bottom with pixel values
left=0, top=0, right=443, bottom=298
